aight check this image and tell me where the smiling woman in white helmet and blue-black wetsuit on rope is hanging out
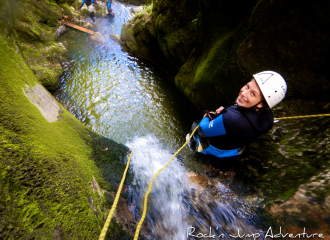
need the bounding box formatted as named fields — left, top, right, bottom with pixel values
left=186, top=71, right=287, bottom=158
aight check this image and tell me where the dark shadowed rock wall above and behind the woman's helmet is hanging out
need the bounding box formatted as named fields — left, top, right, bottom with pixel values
left=122, top=0, right=330, bottom=110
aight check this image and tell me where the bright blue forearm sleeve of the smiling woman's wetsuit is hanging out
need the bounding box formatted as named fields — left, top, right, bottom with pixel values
left=199, top=115, right=226, bottom=137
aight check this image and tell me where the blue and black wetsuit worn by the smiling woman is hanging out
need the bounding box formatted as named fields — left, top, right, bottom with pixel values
left=193, top=105, right=274, bottom=158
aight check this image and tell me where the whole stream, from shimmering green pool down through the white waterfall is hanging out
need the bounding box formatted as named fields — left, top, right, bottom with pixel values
left=54, top=3, right=262, bottom=240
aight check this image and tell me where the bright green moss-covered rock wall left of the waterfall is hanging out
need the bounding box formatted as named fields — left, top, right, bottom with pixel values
left=0, top=1, right=131, bottom=239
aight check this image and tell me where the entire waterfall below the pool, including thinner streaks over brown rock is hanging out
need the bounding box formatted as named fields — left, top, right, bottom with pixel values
left=126, top=135, right=262, bottom=240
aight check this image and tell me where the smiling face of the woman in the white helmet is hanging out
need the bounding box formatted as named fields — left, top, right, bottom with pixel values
left=236, top=80, right=262, bottom=108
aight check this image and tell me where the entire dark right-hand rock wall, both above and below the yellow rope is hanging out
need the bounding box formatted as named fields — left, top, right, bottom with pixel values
left=121, top=0, right=330, bottom=229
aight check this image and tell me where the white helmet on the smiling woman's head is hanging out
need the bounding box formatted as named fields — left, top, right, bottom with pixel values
left=253, top=71, right=287, bottom=108
